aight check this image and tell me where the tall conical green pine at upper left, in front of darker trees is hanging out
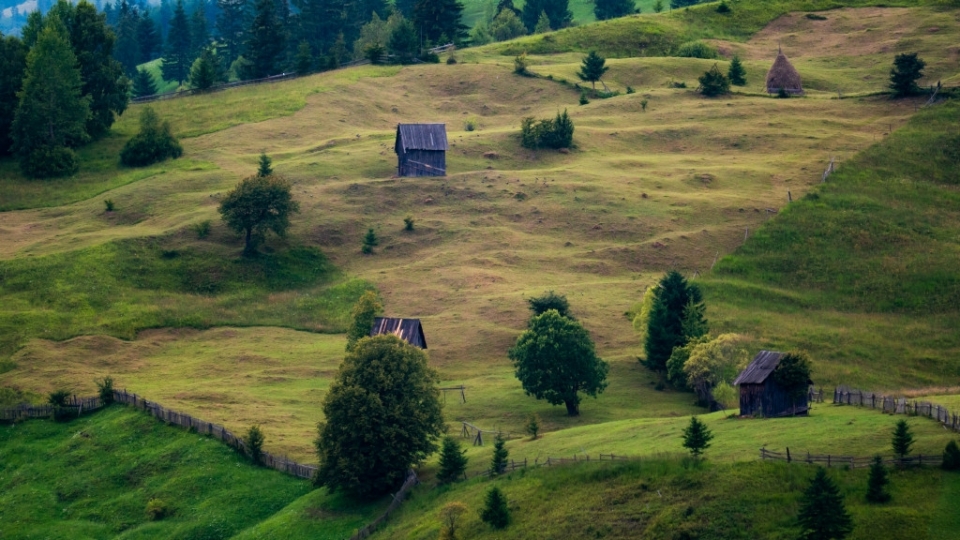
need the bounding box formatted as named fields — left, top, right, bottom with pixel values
left=11, top=16, right=90, bottom=177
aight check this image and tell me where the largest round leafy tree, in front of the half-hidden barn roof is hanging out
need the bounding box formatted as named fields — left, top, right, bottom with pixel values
left=314, top=335, right=444, bottom=499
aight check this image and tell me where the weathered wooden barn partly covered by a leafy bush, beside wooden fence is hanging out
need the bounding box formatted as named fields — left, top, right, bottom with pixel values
left=733, top=351, right=812, bottom=418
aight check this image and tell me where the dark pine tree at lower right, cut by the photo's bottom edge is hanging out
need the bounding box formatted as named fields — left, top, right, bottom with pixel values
left=797, top=467, right=853, bottom=540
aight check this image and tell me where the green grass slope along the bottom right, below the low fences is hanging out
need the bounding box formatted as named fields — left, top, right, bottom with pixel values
left=379, top=457, right=960, bottom=540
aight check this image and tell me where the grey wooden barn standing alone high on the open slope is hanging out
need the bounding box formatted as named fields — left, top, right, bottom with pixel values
left=393, top=124, right=450, bottom=176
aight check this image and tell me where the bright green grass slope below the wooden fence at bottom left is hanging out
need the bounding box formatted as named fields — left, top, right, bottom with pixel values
left=0, top=405, right=379, bottom=540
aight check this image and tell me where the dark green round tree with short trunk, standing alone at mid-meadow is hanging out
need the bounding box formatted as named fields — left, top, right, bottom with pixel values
left=509, top=309, right=609, bottom=416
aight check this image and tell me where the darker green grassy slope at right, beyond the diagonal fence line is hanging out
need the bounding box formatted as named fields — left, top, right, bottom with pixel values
left=704, top=103, right=960, bottom=387
